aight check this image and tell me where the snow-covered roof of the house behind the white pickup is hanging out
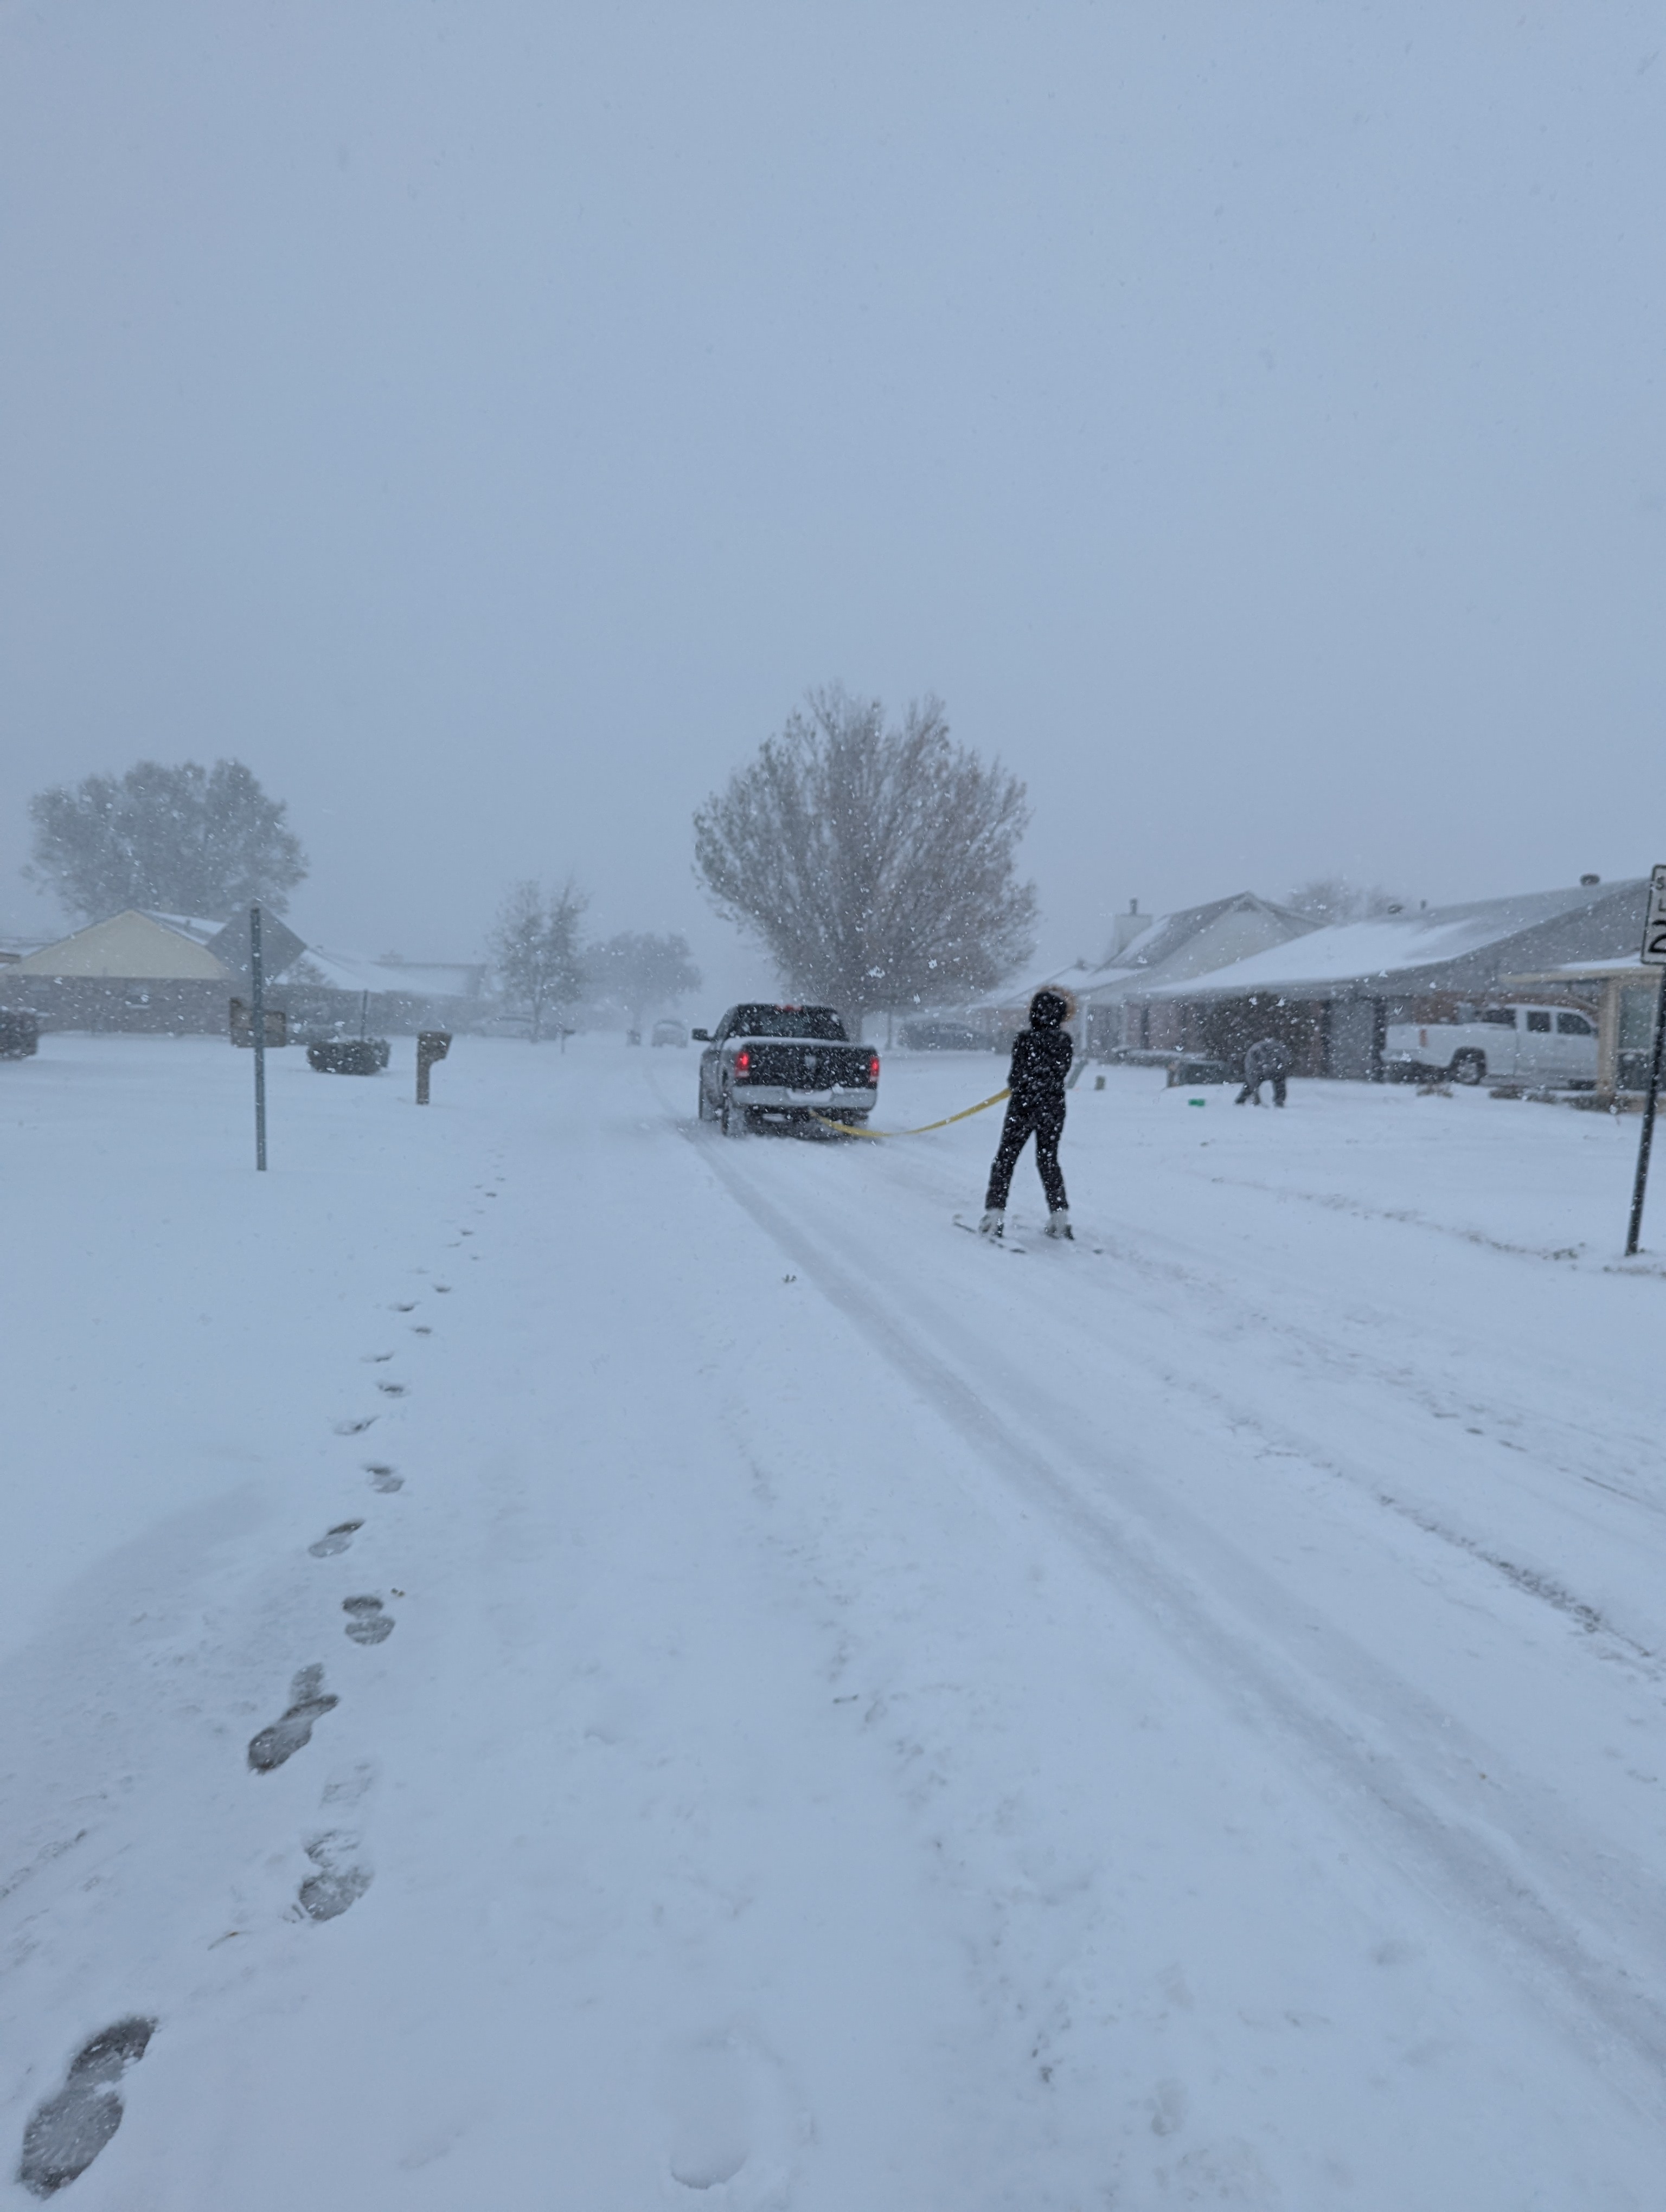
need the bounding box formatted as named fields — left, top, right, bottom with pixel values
left=1150, top=883, right=1644, bottom=998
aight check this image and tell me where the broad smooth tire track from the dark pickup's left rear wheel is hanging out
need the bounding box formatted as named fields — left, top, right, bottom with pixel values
left=682, top=1124, right=1666, bottom=2114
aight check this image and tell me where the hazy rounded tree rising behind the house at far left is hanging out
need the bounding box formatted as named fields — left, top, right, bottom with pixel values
left=24, top=761, right=307, bottom=920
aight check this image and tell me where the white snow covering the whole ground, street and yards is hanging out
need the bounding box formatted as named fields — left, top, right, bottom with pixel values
left=0, top=1035, right=1666, bottom=2212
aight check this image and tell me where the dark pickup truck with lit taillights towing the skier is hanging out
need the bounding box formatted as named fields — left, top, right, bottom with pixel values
left=695, top=1004, right=879, bottom=1137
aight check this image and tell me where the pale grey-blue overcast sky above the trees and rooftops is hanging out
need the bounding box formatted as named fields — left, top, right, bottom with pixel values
left=0, top=0, right=1666, bottom=989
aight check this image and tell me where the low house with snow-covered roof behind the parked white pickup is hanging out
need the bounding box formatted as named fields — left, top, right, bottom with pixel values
left=1150, top=878, right=1648, bottom=1082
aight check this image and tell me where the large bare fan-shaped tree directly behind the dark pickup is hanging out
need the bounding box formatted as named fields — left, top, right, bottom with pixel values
left=695, top=686, right=1035, bottom=1022
